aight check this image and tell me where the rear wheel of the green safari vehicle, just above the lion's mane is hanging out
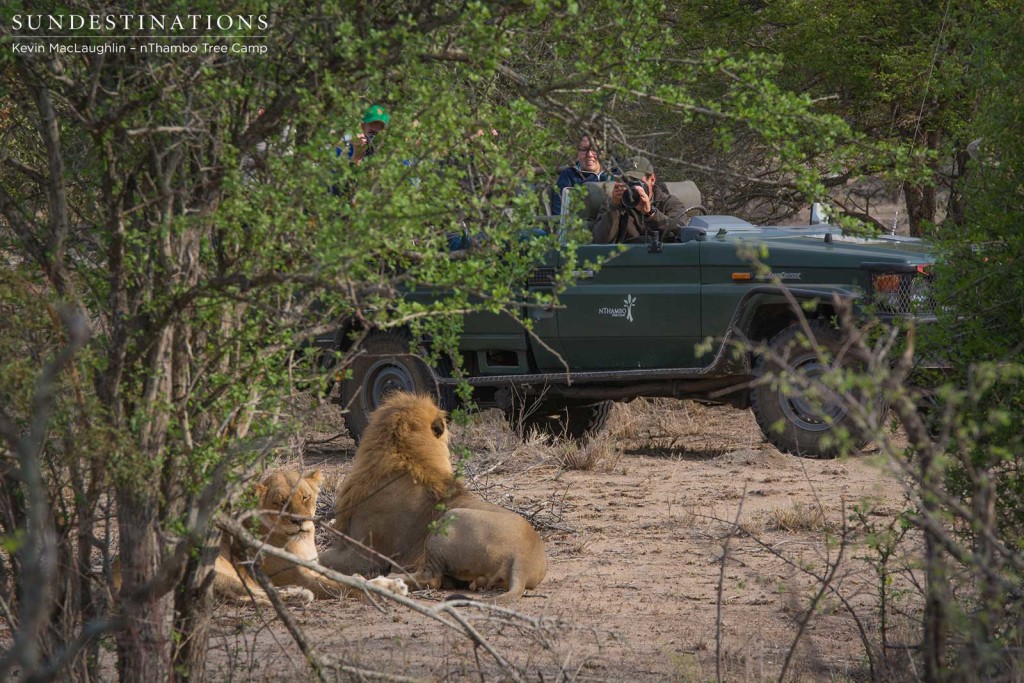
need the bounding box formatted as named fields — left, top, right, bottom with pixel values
left=340, top=332, right=452, bottom=443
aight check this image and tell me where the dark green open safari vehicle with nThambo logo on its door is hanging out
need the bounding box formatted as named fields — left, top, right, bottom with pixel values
left=319, top=183, right=934, bottom=457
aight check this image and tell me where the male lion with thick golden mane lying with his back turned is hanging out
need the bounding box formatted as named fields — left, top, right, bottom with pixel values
left=321, top=392, right=548, bottom=602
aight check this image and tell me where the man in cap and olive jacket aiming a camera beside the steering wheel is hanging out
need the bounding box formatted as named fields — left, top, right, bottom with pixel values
left=591, top=157, right=686, bottom=245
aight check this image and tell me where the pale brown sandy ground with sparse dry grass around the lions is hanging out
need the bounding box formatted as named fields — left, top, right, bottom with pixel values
left=201, top=401, right=914, bottom=681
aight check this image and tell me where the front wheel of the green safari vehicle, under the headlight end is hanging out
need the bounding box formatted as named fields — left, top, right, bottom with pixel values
left=751, top=324, right=887, bottom=458
